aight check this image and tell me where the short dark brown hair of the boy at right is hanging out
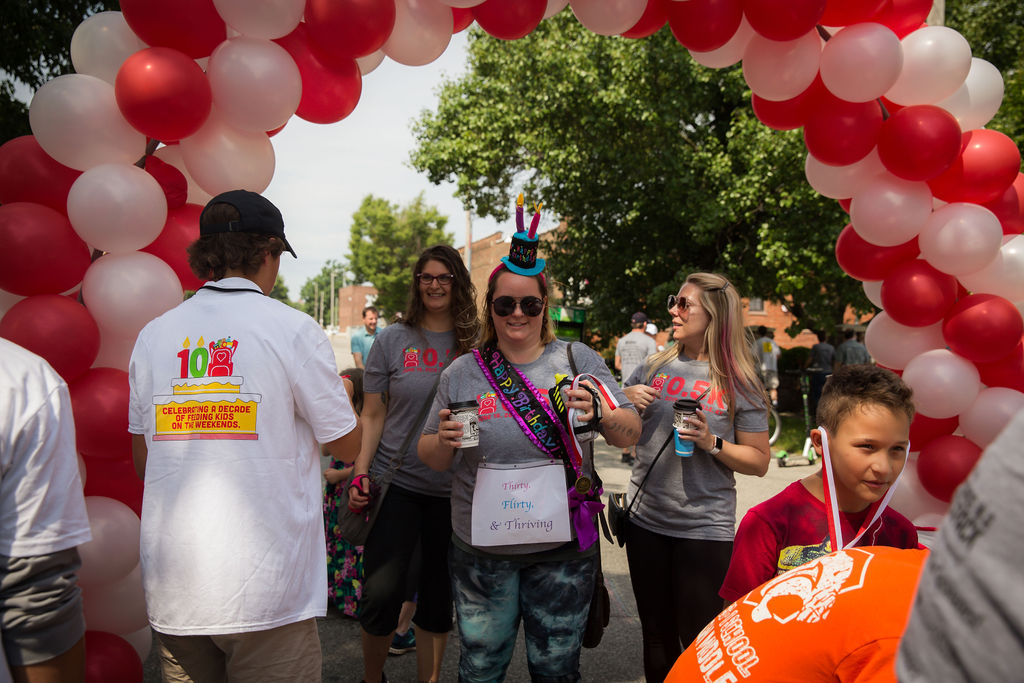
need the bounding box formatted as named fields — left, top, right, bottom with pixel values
left=815, top=366, right=913, bottom=435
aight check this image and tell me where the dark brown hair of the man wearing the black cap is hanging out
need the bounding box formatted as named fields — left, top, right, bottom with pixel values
left=186, top=204, right=285, bottom=280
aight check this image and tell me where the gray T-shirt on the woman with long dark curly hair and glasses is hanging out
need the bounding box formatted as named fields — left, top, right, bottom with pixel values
left=362, top=323, right=456, bottom=496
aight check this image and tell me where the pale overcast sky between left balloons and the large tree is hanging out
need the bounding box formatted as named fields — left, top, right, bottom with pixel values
left=264, top=32, right=503, bottom=299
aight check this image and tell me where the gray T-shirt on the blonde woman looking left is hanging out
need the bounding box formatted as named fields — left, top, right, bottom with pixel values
left=626, top=356, right=768, bottom=541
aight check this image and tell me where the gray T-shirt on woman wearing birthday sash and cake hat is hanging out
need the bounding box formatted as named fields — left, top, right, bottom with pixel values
left=421, top=341, right=634, bottom=555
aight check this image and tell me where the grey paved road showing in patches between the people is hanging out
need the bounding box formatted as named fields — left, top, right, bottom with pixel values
left=143, top=335, right=811, bottom=683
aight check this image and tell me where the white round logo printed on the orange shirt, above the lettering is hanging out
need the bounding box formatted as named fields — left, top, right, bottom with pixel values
left=742, top=548, right=872, bottom=624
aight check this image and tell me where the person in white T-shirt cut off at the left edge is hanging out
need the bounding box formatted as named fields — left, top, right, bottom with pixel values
left=0, top=339, right=92, bottom=681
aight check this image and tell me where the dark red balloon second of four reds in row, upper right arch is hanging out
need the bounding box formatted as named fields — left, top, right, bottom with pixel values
left=802, top=95, right=882, bottom=166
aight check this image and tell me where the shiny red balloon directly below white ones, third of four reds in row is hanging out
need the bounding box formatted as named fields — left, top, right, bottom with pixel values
left=879, top=104, right=961, bottom=180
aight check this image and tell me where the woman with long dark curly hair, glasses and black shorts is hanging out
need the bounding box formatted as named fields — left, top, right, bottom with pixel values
left=348, top=245, right=479, bottom=683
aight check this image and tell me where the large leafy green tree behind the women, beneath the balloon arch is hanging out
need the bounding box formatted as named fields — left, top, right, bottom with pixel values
left=412, top=17, right=869, bottom=342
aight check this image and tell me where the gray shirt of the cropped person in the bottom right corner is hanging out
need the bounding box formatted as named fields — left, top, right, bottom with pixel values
left=896, top=412, right=1024, bottom=683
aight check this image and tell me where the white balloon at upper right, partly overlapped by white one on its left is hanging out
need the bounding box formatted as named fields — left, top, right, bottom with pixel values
left=886, top=26, right=971, bottom=106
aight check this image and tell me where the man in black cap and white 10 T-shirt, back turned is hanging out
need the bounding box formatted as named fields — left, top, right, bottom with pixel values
left=128, top=190, right=361, bottom=681
